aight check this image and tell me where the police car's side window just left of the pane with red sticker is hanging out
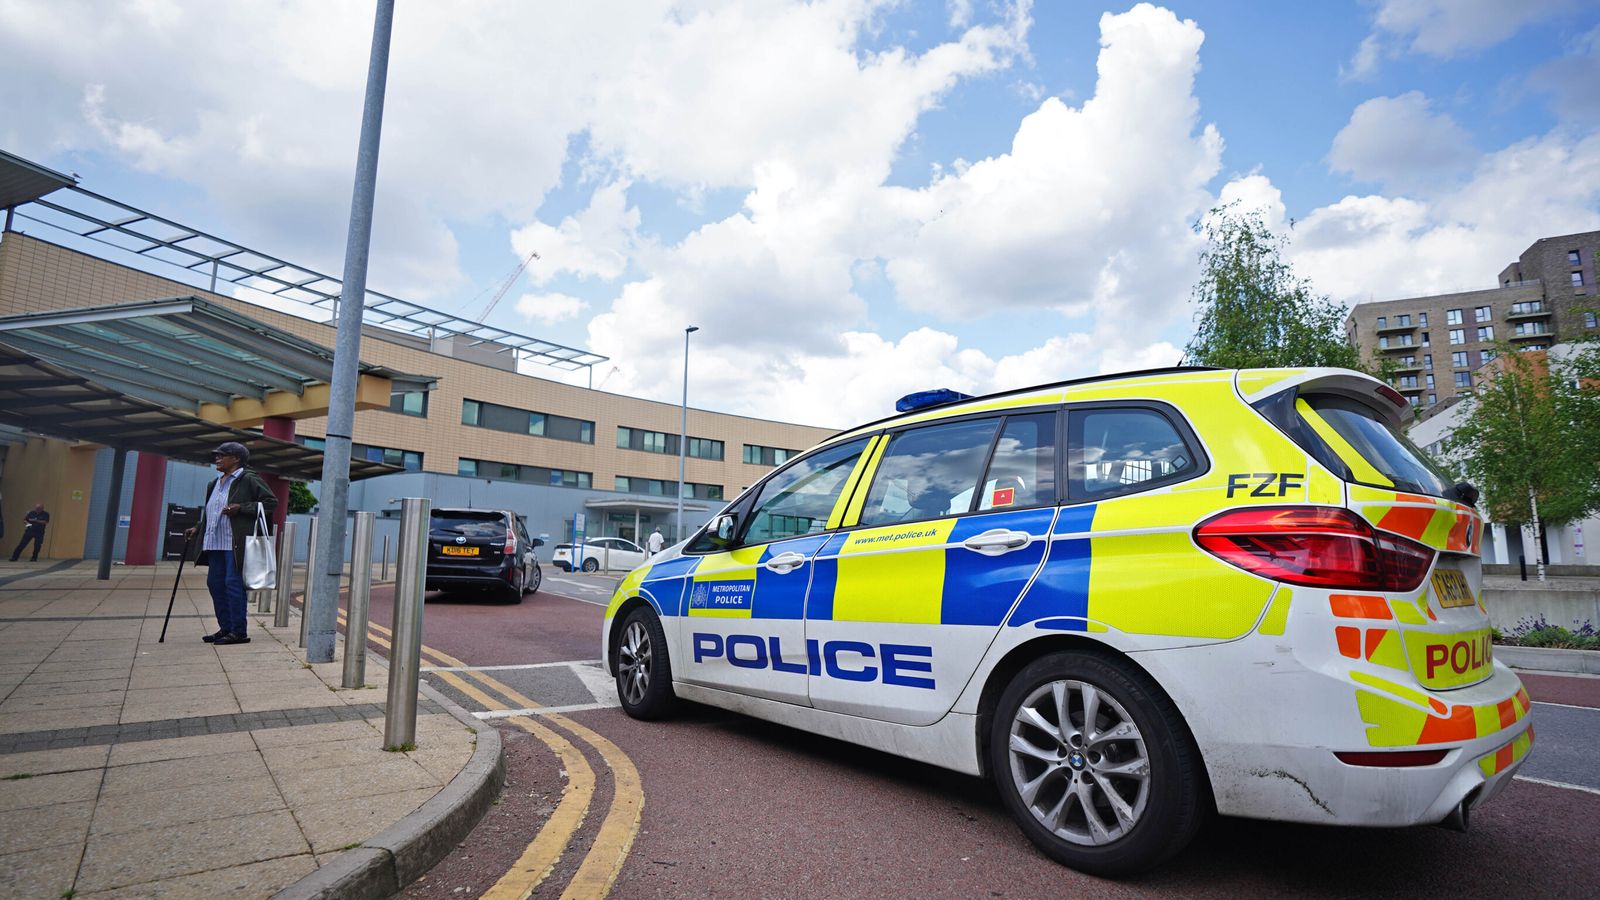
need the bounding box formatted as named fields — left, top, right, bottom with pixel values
left=861, top=418, right=1000, bottom=525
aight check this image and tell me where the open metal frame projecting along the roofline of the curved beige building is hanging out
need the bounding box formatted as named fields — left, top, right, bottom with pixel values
left=0, top=151, right=610, bottom=373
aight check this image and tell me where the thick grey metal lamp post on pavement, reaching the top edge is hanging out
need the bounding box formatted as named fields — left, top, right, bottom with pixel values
left=306, top=0, right=395, bottom=663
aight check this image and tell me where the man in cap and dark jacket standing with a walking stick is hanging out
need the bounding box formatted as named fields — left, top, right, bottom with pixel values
left=184, top=440, right=278, bottom=645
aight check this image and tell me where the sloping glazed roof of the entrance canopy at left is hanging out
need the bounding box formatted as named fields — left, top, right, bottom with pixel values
left=0, top=296, right=434, bottom=415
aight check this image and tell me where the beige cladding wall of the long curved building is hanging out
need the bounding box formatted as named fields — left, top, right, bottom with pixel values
left=0, top=234, right=837, bottom=496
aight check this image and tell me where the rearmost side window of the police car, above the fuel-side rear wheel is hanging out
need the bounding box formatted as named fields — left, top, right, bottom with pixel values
left=1067, top=407, right=1198, bottom=500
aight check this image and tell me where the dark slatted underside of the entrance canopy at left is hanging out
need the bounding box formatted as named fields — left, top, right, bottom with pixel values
left=0, top=348, right=405, bottom=480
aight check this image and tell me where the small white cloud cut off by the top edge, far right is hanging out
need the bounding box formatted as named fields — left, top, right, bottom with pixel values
left=1374, top=0, right=1574, bottom=59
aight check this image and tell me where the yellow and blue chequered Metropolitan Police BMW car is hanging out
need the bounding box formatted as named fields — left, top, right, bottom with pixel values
left=602, top=368, right=1533, bottom=874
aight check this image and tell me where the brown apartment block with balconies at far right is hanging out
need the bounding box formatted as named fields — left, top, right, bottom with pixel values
left=1346, top=231, right=1600, bottom=408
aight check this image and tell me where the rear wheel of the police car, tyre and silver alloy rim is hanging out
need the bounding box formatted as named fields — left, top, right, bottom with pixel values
left=989, top=652, right=1206, bottom=876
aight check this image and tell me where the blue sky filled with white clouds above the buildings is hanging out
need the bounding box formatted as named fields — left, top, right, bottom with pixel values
left=0, top=0, right=1600, bottom=426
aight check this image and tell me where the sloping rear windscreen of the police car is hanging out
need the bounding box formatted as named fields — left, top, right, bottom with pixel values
left=1296, top=394, right=1451, bottom=496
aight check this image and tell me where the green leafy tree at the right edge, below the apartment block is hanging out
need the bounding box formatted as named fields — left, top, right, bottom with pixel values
left=1445, top=346, right=1600, bottom=525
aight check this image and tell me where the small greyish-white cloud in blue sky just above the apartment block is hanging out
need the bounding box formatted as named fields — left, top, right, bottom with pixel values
left=1328, top=91, right=1478, bottom=187
